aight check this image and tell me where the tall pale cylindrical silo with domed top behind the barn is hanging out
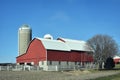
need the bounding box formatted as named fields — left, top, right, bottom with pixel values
left=18, top=24, right=32, bottom=55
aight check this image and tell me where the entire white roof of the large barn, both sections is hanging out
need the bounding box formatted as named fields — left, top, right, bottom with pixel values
left=37, top=37, right=93, bottom=51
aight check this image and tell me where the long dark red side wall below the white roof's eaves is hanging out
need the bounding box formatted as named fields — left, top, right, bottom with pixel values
left=47, top=50, right=93, bottom=62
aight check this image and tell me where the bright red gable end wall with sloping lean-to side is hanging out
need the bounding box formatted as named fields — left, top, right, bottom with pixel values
left=17, top=38, right=46, bottom=65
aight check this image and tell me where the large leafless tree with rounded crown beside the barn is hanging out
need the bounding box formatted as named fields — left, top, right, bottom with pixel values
left=87, top=35, right=118, bottom=69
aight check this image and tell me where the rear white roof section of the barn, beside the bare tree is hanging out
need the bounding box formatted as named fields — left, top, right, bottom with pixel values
left=60, top=38, right=93, bottom=51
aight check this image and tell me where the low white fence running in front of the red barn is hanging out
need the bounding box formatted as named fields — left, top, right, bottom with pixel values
left=0, top=64, right=96, bottom=71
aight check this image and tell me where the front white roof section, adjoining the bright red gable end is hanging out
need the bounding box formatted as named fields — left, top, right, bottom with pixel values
left=37, top=37, right=70, bottom=51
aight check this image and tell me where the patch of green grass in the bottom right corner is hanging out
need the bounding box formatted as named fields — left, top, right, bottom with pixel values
left=90, top=73, right=120, bottom=80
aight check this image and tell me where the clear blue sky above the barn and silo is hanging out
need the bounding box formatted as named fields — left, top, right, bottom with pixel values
left=0, top=0, right=120, bottom=63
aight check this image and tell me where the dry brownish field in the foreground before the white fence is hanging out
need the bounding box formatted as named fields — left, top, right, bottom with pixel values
left=0, top=70, right=120, bottom=80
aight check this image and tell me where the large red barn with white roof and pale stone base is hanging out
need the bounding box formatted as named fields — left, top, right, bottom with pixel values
left=16, top=38, right=93, bottom=70
